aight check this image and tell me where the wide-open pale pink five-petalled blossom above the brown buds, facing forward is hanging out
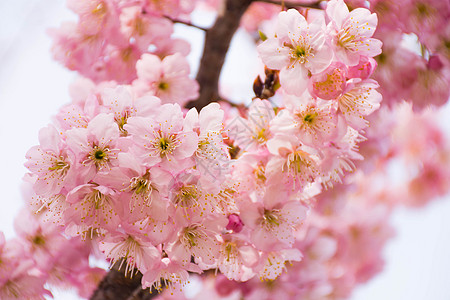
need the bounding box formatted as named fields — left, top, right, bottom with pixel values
left=258, top=9, right=333, bottom=96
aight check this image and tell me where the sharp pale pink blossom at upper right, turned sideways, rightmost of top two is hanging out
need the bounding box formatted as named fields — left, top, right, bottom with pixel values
left=326, top=0, right=382, bottom=66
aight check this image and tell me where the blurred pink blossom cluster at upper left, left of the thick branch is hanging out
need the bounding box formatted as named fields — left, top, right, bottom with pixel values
left=50, top=0, right=193, bottom=83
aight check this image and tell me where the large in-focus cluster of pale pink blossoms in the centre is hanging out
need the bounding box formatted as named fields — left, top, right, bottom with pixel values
left=21, top=2, right=381, bottom=288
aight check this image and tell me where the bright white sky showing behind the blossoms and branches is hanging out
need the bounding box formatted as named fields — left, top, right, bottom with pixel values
left=0, top=0, right=450, bottom=300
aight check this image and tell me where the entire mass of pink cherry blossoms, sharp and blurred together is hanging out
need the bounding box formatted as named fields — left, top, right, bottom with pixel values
left=4, top=0, right=450, bottom=300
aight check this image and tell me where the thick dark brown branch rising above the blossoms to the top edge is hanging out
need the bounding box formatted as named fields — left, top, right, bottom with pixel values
left=187, top=0, right=253, bottom=110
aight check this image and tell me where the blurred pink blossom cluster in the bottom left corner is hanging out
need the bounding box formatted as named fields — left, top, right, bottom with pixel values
left=0, top=209, right=105, bottom=300
